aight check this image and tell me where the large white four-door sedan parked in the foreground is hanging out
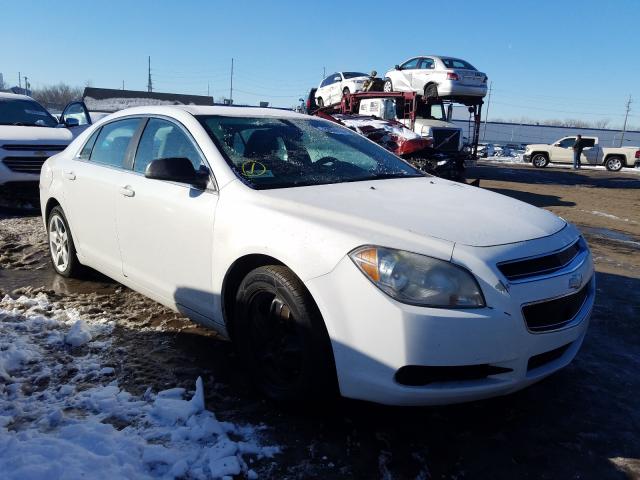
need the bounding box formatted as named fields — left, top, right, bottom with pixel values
left=40, top=106, right=595, bottom=405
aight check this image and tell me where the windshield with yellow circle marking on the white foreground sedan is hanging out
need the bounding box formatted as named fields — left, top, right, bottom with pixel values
left=199, top=116, right=424, bottom=189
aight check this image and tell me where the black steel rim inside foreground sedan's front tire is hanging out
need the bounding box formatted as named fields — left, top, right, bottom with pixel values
left=249, top=291, right=303, bottom=388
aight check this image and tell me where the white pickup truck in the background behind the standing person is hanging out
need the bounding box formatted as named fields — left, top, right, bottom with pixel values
left=523, top=137, right=640, bottom=172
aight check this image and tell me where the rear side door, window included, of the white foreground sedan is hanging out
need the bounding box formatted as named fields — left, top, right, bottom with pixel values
left=62, top=118, right=141, bottom=276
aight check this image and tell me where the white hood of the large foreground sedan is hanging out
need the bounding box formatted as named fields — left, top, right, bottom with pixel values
left=261, top=177, right=566, bottom=247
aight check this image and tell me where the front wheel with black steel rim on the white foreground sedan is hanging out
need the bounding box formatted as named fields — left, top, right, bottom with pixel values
left=233, top=265, right=336, bottom=402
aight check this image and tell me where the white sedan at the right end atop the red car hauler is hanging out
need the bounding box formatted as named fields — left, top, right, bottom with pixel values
left=384, top=55, right=487, bottom=99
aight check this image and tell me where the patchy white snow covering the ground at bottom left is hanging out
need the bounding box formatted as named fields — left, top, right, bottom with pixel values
left=0, top=293, right=280, bottom=480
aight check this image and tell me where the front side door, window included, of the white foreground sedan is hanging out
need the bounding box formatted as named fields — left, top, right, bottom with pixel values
left=117, top=118, right=219, bottom=320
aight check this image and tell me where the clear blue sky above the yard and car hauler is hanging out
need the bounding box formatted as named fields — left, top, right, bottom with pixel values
left=0, top=0, right=640, bottom=126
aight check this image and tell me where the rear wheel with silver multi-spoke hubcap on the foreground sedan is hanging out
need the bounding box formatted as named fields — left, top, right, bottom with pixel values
left=47, top=206, right=82, bottom=277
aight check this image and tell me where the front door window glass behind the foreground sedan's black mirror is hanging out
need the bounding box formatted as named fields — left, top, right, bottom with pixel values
left=133, top=118, right=203, bottom=173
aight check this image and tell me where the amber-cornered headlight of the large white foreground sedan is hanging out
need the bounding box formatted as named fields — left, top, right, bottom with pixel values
left=349, top=246, right=485, bottom=308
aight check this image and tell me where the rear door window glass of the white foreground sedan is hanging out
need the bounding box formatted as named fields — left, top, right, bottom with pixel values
left=91, top=118, right=140, bottom=168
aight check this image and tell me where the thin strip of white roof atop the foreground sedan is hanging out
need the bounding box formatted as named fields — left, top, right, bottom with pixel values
left=107, top=105, right=311, bottom=119
